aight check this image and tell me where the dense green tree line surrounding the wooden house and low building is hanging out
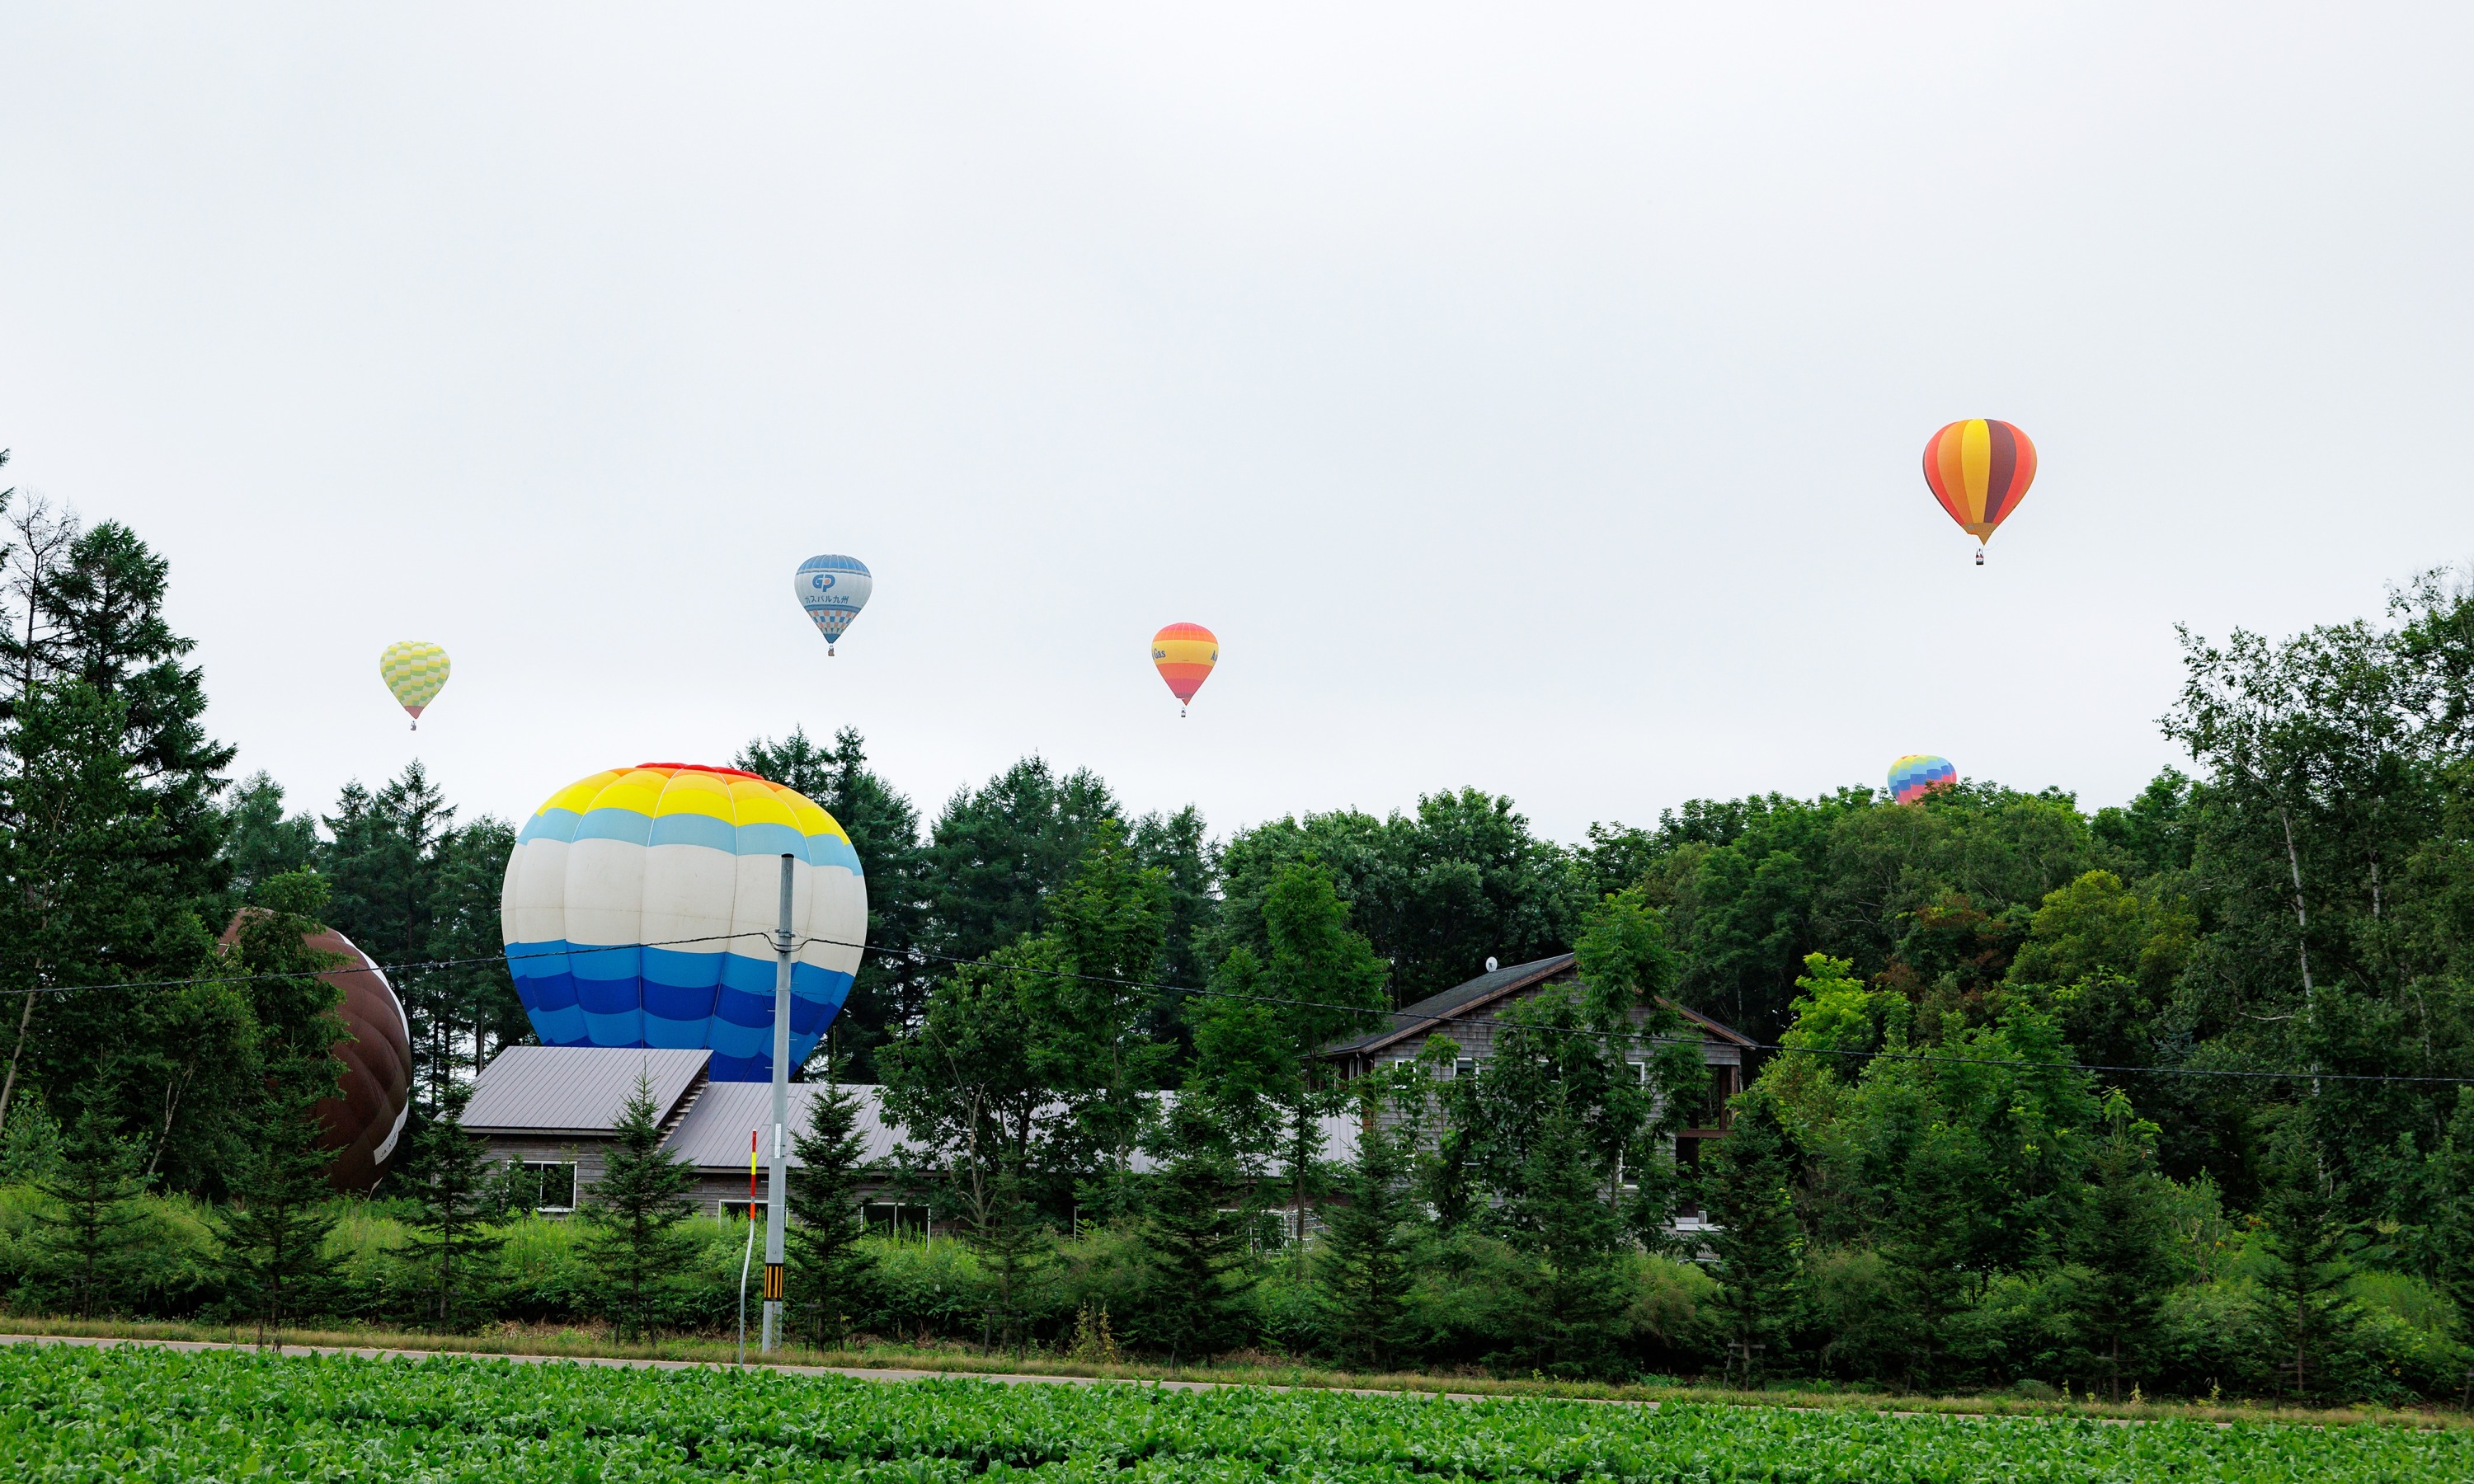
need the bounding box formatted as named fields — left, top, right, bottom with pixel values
left=0, top=467, right=2474, bottom=1395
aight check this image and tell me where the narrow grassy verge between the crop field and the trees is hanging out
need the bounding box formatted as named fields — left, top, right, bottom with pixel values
left=0, top=1313, right=2474, bottom=1430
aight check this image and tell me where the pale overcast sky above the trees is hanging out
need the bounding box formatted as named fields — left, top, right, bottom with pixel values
left=0, top=0, right=2474, bottom=841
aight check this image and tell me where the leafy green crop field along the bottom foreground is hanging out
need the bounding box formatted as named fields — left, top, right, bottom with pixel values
left=0, top=1345, right=2474, bottom=1484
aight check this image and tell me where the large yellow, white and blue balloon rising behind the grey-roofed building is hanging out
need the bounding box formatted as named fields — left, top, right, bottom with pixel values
left=500, top=762, right=868, bottom=1081
